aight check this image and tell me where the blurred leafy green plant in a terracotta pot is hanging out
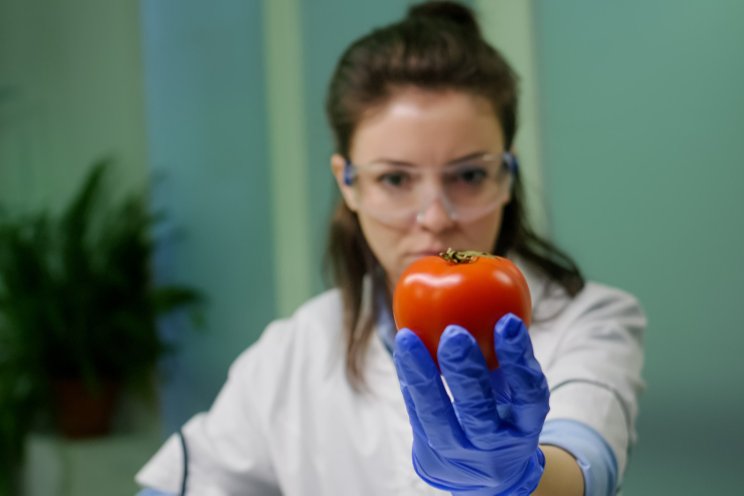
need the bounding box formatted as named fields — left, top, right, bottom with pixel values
left=0, top=160, right=200, bottom=446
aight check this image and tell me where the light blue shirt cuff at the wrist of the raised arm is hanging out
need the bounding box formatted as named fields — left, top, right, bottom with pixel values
left=540, top=419, right=618, bottom=496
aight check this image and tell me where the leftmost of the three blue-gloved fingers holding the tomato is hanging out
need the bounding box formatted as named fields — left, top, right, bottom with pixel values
left=393, top=329, right=463, bottom=449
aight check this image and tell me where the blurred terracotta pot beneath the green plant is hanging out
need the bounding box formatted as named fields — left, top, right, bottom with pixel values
left=54, top=379, right=119, bottom=439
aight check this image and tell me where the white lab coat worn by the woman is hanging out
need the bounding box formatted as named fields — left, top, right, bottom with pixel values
left=136, top=265, right=645, bottom=496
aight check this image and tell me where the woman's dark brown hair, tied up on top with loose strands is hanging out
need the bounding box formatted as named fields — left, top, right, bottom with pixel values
left=326, top=1, right=584, bottom=388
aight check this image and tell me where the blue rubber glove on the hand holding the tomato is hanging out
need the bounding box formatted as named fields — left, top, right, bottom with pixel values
left=394, top=314, right=549, bottom=496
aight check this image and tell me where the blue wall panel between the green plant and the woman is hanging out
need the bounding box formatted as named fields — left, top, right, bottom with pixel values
left=141, top=0, right=274, bottom=431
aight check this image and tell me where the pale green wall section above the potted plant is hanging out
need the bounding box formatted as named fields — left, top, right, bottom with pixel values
left=0, top=0, right=148, bottom=210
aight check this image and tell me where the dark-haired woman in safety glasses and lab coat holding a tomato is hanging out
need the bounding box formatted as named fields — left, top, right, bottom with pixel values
left=137, top=2, right=645, bottom=495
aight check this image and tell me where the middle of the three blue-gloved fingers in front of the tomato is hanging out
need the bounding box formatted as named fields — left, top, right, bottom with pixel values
left=437, top=325, right=499, bottom=450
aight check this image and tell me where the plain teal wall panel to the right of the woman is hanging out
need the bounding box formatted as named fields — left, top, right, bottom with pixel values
left=535, top=0, right=744, bottom=494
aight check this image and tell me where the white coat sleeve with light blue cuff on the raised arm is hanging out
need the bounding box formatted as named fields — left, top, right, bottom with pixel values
left=535, top=283, right=645, bottom=486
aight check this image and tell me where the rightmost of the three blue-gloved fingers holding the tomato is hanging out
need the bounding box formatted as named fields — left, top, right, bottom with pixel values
left=494, top=314, right=550, bottom=432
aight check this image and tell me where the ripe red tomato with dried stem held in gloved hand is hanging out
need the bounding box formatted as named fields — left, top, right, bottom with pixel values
left=393, top=249, right=532, bottom=370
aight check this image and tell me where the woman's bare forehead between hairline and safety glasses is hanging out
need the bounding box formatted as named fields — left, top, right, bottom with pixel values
left=350, top=88, right=503, bottom=162
